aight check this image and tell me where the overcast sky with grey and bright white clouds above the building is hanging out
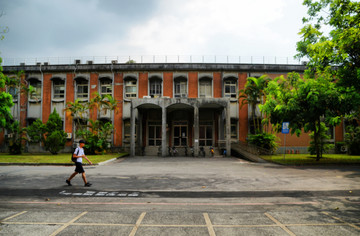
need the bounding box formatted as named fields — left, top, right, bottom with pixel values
left=0, top=0, right=306, bottom=58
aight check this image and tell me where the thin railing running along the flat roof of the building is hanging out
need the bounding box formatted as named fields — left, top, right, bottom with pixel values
left=2, top=55, right=305, bottom=66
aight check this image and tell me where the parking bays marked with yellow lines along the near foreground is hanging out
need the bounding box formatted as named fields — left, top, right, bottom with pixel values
left=0, top=208, right=360, bottom=236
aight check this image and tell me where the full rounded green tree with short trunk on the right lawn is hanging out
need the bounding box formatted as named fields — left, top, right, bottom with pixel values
left=260, top=73, right=360, bottom=160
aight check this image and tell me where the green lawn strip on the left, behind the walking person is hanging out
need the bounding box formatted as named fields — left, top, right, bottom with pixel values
left=0, top=153, right=127, bottom=164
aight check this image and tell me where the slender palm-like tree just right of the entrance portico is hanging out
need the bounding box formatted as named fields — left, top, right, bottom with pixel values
left=239, top=75, right=270, bottom=134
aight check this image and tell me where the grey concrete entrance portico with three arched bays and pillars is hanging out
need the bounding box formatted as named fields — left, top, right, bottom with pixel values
left=130, top=98, right=231, bottom=157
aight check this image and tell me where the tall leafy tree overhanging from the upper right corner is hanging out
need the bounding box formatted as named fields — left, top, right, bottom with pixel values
left=296, top=0, right=360, bottom=155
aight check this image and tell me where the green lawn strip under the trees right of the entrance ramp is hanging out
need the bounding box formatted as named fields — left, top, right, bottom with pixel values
left=261, top=154, right=360, bottom=165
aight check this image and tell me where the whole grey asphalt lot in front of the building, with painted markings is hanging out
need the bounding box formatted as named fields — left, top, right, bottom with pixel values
left=0, top=157, right=360, bottom=235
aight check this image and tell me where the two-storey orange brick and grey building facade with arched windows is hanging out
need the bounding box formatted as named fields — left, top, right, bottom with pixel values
left=0, top=61, right=343, bottom=156
